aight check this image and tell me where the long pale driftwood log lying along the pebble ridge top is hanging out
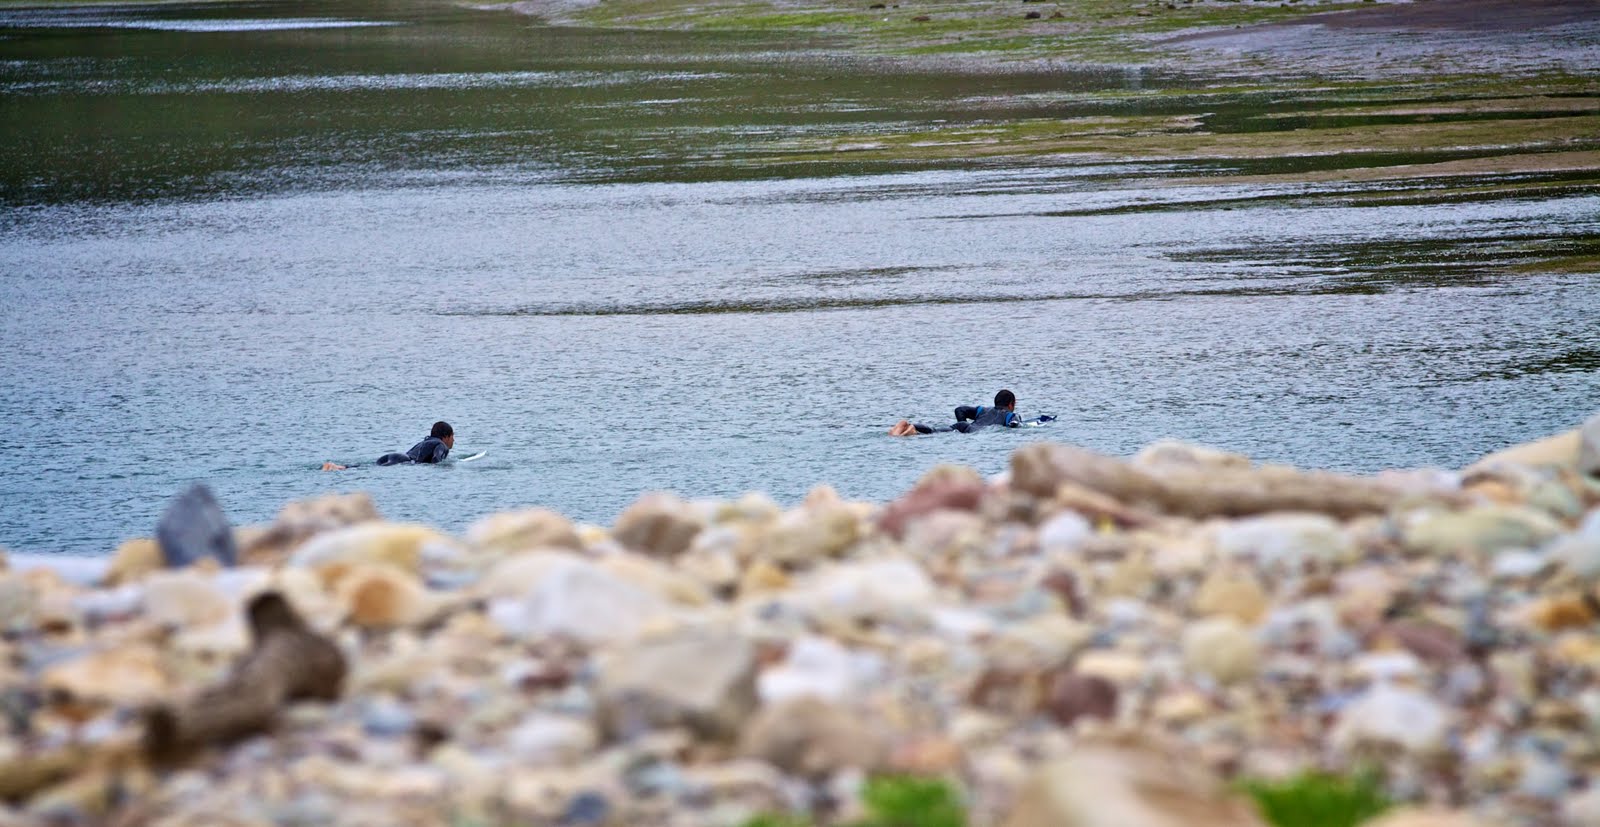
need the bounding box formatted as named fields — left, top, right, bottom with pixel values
left=1011, top=443, right=1420, bottom=518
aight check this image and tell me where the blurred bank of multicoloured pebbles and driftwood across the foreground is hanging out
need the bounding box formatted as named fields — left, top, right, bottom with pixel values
left=0, top=416, right=1600, bottom=827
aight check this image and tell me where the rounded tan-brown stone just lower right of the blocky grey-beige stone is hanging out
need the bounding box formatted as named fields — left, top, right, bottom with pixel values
left=739, top=697, right=888, bottom=779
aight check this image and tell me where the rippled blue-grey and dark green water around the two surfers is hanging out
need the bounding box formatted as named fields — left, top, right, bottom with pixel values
left=0, top=3, right=1600, bottom=553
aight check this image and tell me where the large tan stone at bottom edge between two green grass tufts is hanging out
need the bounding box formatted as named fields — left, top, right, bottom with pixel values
left=1005, top=742, right=1266, bottom=827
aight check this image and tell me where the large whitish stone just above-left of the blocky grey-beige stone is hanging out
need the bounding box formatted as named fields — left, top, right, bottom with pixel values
left=490, top=557, right=674, bottom=645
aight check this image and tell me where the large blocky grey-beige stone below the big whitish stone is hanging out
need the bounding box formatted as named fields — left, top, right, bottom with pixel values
left=595, top=633, right=757, bottom=739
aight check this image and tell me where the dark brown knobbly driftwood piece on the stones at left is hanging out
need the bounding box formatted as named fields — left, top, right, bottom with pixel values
left=144, top=592, right=346, bottom=765
